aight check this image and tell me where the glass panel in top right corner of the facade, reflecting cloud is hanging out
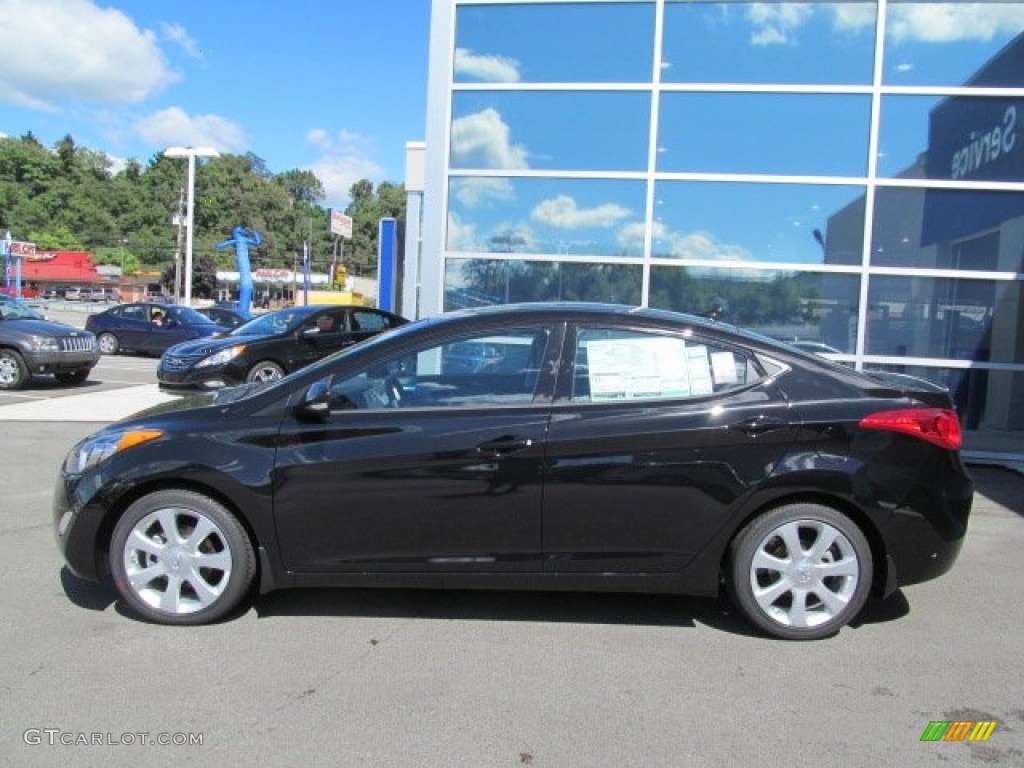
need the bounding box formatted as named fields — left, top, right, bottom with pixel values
left=883, top=0, right=1024, bottom=87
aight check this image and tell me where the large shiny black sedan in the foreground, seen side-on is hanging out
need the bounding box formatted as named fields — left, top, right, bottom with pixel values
left=53, top=304, right=973, bottom=639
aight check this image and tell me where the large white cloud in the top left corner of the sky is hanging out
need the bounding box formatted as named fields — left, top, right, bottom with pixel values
left=0, top=0, right=178, bottom=112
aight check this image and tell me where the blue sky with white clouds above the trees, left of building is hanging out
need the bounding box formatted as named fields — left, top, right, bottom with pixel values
left=0, top=0, right=430, bottom=205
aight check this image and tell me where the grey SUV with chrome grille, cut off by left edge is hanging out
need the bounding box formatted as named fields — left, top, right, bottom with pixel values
left=0, top=296, right=99, bottom=389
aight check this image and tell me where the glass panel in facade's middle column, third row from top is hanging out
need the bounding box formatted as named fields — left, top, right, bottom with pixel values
left=652, top=181, right=864, bottom=264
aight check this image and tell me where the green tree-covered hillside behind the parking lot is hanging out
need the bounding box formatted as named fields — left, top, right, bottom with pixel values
left=0, top=133, right=406, bottom=288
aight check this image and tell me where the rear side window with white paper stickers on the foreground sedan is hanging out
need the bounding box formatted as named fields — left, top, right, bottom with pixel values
left=571, top=328, right=758, bottom=402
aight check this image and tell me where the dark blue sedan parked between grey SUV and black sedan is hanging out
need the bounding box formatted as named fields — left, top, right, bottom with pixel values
left=85, top=302, right=227, bottom=354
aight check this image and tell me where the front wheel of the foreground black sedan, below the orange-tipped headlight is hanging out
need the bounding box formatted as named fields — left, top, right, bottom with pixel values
left=110, top=490, right=256, bottom=625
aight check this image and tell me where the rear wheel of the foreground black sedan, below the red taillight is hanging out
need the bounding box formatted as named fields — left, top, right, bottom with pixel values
left=727, top=504, right=873, bottom=640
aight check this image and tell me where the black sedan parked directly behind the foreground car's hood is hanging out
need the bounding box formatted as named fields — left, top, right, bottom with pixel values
left=157, top=304, right=406, bottom=389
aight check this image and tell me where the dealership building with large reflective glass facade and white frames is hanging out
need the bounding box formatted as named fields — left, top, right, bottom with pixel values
left=399, top=0, right=1024, bottom=461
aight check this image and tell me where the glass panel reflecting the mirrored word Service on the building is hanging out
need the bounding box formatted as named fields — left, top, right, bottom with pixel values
left=879, top=94, right=1024, bottom=181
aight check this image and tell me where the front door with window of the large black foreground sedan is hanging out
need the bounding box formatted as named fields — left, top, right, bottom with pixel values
left=272, top=325, right=558, bottom=573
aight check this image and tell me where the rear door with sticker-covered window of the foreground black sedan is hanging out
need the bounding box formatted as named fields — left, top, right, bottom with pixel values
left=544, top=326, right=795, bottom=572
